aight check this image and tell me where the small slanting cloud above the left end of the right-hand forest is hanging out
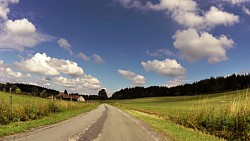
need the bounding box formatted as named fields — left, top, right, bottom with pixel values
left=118, top=70, right=146, bottom=86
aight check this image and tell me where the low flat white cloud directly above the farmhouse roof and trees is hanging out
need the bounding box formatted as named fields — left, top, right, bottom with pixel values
left=55, top=75, right=101, bottom=91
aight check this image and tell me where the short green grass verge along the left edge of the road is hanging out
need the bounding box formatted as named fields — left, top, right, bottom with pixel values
left=0, top=103, right=99, bottom=137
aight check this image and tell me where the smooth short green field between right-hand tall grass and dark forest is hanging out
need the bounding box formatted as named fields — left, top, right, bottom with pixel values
left=109, top=90, right=246, bottom=115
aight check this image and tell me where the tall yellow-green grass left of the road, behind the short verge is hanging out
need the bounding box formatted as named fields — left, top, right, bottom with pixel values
left=0, top=96, right=88, bottom=125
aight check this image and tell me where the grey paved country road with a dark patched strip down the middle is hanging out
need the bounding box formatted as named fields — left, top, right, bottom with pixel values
left=0, top=104, right=166, bottom=141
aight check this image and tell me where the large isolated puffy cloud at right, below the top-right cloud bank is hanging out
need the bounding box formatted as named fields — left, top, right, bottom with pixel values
left=173, top=28, right=234, bottom=63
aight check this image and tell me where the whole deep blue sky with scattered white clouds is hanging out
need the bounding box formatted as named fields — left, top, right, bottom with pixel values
left=0, top=0, right=250, bottom=95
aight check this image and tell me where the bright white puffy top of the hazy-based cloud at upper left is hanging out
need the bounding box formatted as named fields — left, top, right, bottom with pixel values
left=5, top=18, right=36, bottom=34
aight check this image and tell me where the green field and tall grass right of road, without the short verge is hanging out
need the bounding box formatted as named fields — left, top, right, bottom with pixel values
left=112, top=89, right=250, bottom=141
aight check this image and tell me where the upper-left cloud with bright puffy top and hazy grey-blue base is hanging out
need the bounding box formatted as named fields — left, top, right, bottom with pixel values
left=0, top=18, right=52, bottom=51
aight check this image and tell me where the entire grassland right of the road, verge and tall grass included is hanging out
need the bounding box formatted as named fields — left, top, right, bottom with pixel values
left=109, top=89, right=250, bottom=141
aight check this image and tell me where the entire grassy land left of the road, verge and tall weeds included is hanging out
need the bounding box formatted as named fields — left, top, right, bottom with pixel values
left=0, top=92, right=99, bottom=137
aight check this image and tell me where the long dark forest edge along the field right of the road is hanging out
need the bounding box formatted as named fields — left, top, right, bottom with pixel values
left=111, top=74, right=250, bottom=99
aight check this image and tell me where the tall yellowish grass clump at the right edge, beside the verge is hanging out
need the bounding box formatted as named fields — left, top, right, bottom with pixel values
left=186, top=91, right=250, bottom=141
